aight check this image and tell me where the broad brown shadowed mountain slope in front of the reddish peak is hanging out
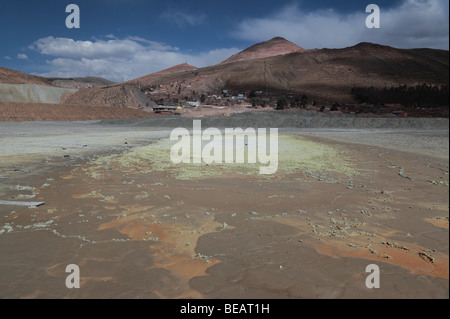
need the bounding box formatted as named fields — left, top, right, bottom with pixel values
left=128, top=40, right=449, bottom=103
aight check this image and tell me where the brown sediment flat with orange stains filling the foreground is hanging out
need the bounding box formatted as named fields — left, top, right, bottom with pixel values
left=0, top=127, right=448, bottom=298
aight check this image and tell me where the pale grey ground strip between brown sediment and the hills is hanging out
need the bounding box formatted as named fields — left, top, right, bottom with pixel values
left=0, top=112, right=449, bottom=167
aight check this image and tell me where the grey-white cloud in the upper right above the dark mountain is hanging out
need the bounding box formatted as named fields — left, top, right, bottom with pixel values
left=231, top=0, right=449, bottom=50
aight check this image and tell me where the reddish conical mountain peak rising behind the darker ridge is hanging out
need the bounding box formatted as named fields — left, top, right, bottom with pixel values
left=220, top=37, right=306, bottom=64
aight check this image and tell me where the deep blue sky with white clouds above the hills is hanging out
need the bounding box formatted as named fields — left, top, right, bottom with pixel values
left=0, top=0, right=449, bottom=81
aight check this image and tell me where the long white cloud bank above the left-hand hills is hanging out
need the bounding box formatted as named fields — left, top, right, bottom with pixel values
left=31, top=35, right=240, bottom=81
